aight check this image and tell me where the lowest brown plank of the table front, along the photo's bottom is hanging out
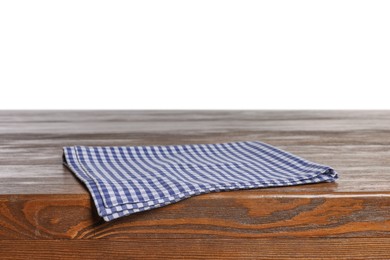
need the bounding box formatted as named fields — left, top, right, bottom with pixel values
left=0, top=238, right=390, bottom=260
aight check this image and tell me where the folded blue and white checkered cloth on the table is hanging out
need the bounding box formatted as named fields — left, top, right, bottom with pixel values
left=64, top=142, right=338, bottom=221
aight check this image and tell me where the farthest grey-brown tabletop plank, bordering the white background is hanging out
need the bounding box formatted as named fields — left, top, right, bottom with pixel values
left=0, top=111, right=390, bottom=135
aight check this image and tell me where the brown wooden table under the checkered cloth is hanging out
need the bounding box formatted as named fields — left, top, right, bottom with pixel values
left=0, top=111, right=390, bottom=259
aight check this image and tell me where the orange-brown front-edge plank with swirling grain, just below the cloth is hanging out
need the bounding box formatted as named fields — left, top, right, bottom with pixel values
left=0, top=192, right=390, bottom=239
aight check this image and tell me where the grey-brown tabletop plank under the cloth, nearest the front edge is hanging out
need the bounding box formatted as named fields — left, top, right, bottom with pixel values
left=0, top=145, right=390, bottom=194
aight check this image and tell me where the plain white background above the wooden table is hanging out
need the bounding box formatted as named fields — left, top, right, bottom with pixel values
left=0, top=0, right=390, bottom=109
